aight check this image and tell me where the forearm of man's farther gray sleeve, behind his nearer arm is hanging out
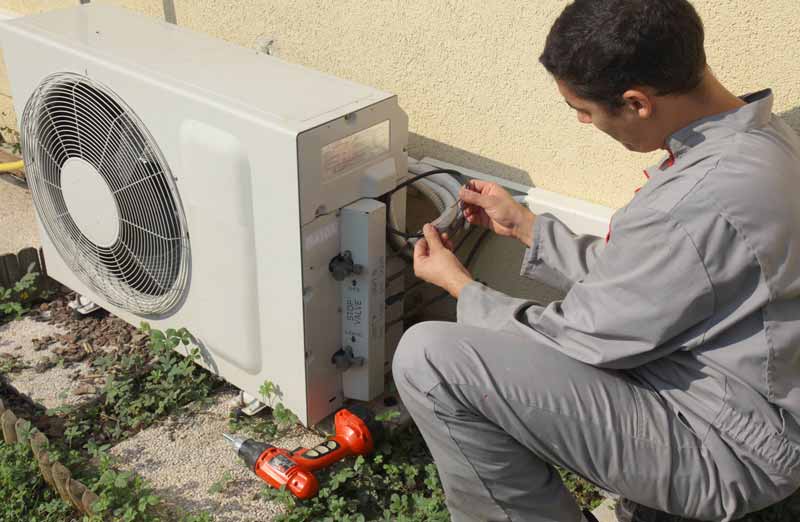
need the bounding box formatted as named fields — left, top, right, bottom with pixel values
left=520, top=214, right=605, bottom=292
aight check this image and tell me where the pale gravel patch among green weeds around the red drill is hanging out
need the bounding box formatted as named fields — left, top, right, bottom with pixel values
left=111, top=391, right=322, bottom=522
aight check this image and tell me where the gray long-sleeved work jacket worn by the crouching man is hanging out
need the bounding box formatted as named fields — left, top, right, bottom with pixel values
left=458, top=90, right=800, bottom=486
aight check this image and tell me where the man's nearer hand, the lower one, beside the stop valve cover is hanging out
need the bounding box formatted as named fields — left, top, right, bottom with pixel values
left=414, top=224, right=472, bottom=299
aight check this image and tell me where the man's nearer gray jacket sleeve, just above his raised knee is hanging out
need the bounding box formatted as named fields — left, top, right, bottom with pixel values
left=457, top=205, right=714, bottom=368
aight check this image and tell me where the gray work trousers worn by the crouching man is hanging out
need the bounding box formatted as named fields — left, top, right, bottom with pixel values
left=393, top=322, right=755, bottom=522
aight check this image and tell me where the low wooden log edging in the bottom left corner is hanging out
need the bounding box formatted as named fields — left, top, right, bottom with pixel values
left=0, top=399, right=99, bottom=515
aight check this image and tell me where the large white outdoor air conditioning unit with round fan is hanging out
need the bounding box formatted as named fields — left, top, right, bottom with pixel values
left=0, top=4, right=408, bottom=423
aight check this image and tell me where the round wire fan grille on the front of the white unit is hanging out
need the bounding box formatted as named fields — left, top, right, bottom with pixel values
left=21, top=73, right=190, bottom=315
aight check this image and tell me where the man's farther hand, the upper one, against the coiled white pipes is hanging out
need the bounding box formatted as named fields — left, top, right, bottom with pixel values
left=459, top=179, right=536, bottom=246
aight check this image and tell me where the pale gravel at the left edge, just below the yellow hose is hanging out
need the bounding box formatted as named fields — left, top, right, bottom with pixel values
left=0, top=174, right=39, bottom=255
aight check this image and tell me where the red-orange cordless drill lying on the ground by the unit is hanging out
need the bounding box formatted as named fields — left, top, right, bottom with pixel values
left=223, top=406, right=381, bottom=500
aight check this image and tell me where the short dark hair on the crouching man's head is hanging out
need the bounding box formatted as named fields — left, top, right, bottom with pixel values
left=539, top=0, right=706, bottom=109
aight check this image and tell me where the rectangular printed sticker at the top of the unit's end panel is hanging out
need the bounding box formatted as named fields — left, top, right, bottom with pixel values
left=322, top=120, right=389, bottom=182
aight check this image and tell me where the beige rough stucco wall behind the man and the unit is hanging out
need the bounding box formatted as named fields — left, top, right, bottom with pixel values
left=0, top=0, right=800, bottom=207
